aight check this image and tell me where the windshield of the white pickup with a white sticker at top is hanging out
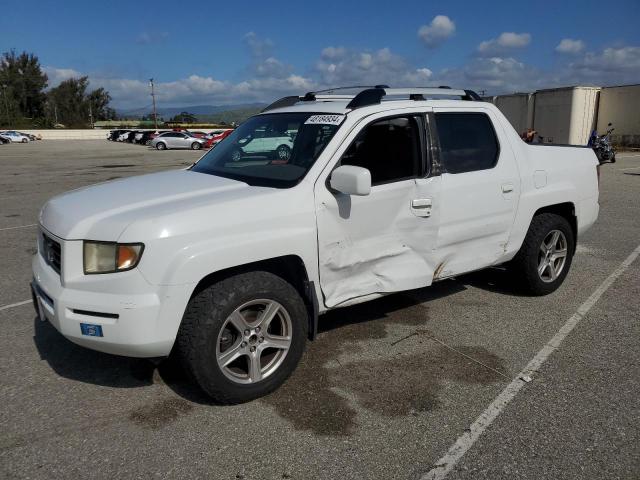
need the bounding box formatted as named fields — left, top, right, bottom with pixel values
left=191, top=112, right=344, bottom=188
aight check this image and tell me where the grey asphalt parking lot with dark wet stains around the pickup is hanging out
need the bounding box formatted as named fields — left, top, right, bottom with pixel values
left=0, top=141, right=640, bottom=479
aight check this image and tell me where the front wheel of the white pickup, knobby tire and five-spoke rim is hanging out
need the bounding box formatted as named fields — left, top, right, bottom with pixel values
left=176, top=272, right=308, bottom=404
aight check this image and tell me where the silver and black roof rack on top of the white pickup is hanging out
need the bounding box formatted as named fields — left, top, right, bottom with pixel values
left=262, top=85, right=482, bottom=112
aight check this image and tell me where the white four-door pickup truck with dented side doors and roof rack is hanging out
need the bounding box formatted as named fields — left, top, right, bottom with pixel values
left=32, top=86, right=599, bottom=403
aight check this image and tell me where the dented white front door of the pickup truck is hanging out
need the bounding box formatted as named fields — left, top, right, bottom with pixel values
left=315, top=112, right=441, bottom=308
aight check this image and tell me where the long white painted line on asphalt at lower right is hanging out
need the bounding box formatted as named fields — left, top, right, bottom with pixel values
left=421, top=245, right=640, bottom=480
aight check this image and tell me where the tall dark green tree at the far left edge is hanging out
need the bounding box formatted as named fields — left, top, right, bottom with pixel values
left=0, top=50, right=48, bottom=123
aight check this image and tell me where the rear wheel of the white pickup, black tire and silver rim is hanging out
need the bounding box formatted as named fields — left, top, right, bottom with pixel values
left=509, top=213, right=575, bottom=296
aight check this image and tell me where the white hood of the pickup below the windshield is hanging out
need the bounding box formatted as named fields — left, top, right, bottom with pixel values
left=40, top=170, right=255, bottom=241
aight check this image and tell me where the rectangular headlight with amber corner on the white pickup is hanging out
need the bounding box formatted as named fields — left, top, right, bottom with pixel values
left=84, top=240, right=144, bottom=275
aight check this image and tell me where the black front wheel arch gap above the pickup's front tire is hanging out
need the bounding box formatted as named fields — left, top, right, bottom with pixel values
left=191, top=255, right=319, bottom=340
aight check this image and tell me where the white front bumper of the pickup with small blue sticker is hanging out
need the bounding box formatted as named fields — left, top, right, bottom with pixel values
left=31, top=248, right=193, bottom=357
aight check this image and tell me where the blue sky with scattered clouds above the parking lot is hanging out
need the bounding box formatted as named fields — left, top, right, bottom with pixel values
left=0, top=0, right=640, bottom=109
